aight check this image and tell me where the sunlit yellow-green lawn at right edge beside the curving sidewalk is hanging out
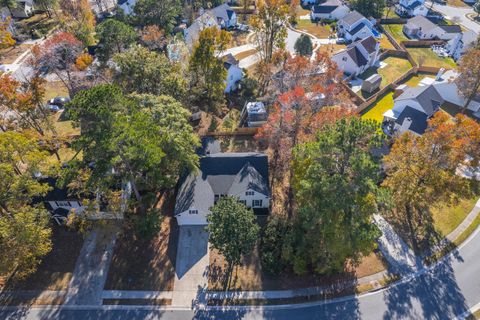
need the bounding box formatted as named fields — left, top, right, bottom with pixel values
left=430, top=195, right=479, bottom=236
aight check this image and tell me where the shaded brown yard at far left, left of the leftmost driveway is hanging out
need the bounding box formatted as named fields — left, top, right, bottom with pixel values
left=5, top=225, right=83, bottom=291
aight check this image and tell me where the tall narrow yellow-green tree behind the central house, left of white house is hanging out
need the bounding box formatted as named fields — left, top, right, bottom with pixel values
left=189, top=27, right=231, bottom=112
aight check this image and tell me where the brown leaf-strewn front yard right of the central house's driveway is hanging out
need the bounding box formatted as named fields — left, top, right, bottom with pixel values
left=208, top=217, right=386, bottom=291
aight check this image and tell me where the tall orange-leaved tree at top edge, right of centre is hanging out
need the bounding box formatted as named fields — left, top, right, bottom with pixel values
left=250, top=0, right=289, bottom=63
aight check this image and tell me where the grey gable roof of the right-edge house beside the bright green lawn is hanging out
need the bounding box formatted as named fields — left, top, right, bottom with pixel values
left=395, top=85, right=445, bottom=116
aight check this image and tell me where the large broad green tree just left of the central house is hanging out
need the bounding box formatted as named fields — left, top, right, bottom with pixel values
left=69, top=85, right=198, bottom=212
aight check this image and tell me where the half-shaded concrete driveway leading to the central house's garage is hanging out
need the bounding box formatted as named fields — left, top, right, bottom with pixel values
left=172, top=226, right=210, bottom=307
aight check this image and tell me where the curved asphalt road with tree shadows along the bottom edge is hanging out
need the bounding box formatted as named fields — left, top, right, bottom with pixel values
left=0, top=224, right=480, bottom=320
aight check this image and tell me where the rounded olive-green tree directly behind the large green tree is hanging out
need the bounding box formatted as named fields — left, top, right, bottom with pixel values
left=113, top=46, right=186, bottom=99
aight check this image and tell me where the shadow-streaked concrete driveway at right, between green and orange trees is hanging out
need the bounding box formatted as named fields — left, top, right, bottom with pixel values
left=373, top=214, right=423, bottom=275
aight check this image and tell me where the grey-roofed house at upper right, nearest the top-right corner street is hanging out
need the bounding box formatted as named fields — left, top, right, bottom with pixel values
left=403, top=16, right=462, bottom=40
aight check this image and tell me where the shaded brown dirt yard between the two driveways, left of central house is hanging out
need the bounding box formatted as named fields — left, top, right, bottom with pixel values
left=105, top=217, right=178, bottom=291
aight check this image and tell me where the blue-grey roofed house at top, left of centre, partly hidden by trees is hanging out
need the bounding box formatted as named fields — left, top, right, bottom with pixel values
left=183, top=4, right=237, bottom=48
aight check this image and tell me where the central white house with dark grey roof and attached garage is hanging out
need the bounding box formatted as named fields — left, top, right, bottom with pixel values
left=174, top=153, right=270, bottom=225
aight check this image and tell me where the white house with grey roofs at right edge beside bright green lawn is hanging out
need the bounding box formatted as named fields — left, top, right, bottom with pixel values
left=382, top=70, right=480, bottom=135
